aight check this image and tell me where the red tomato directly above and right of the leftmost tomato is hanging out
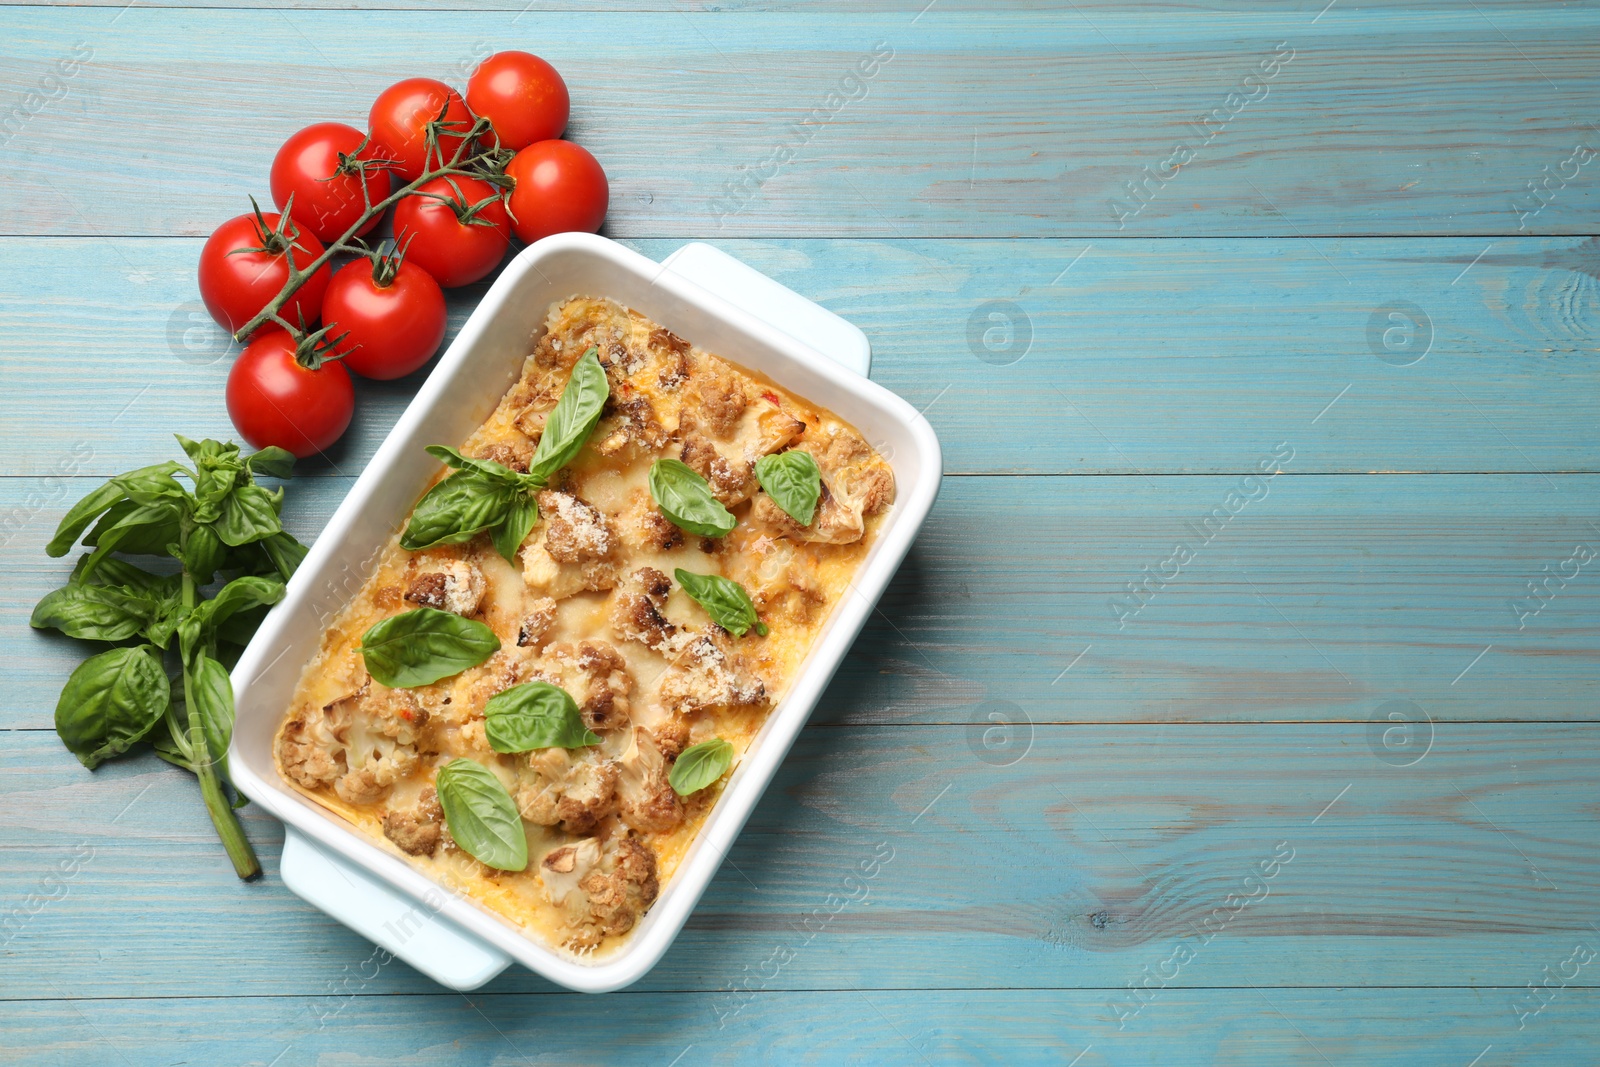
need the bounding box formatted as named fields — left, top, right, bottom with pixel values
left=272, top=122, right=389, bottom=242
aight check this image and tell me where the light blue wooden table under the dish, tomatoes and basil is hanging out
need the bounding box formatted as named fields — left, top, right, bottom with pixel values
left=0, top=0, right=1600, bottom=1067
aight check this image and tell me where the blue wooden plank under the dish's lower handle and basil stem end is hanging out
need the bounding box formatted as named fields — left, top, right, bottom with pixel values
left=0, top=723, right=1600, bottom=1004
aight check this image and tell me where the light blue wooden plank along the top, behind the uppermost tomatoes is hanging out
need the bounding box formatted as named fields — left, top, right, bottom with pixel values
left=0, top=3, right=1600, bottom=238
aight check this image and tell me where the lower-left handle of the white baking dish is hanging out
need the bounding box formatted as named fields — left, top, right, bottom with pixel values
left=282, top=825, right=510, bottom=990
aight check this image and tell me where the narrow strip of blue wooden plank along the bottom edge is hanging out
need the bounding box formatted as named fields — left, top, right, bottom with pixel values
left=0, top=991, right=1600, bottom=1067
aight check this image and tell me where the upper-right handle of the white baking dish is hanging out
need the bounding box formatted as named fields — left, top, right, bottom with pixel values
left=661, top=242, right=872, bottom=378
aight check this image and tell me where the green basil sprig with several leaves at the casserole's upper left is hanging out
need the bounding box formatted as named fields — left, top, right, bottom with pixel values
left=400, top=349, right=611, bottom=563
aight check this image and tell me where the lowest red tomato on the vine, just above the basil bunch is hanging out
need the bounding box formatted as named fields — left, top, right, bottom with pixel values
left=227, top=326, right=355, bottom=459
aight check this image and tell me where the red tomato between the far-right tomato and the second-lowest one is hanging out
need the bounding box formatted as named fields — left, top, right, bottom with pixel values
left=395, top=178, right=510, bottom=290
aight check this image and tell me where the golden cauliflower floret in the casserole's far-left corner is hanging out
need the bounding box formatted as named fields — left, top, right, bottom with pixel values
left=278, top=680, right=427, bottom=805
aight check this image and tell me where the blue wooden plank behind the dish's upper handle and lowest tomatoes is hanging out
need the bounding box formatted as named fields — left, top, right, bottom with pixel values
left=0, top=238, right=1600, bottom=475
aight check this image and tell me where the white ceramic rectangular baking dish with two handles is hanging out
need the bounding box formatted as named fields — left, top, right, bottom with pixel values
left=229, top=234, right=941, bottom=992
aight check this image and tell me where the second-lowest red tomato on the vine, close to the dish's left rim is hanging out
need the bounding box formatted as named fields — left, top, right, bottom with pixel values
left=322, top=256, right=445, bottom=381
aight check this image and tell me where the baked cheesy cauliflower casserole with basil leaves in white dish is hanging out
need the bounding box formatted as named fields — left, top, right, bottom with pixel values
left=275, top=298, right=894, bottom=958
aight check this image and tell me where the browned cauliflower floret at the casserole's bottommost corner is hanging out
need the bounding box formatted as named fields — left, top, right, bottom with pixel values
left=539, top=835, right=661, bottom=949
